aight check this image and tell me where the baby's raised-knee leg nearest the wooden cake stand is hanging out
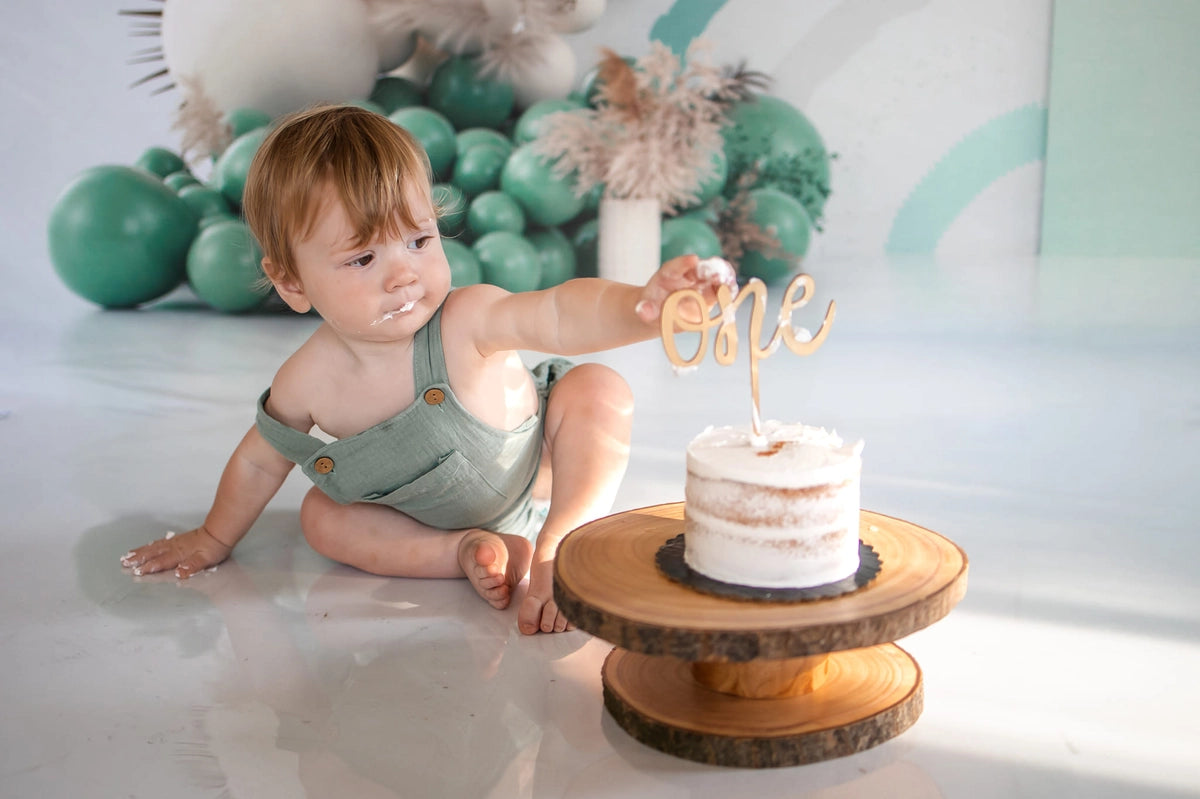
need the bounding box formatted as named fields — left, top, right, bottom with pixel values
left=517, top=364, right=634, bottom=633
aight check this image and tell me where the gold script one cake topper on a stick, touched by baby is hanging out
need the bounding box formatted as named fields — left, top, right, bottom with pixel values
left=661, top=258, right=838, bottom=439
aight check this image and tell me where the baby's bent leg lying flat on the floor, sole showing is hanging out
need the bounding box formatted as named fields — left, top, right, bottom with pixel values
left=300, top=488, right=533, bottom=608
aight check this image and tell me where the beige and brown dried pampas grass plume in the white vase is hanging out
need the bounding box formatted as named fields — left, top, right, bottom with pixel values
left=536, top=38, right=763, bottom=214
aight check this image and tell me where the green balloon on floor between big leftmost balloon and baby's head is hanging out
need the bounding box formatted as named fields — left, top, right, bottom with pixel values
left=187, top=218, right=270, bottom=313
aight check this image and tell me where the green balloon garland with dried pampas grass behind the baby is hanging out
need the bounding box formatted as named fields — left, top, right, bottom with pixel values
left=47, top=11, right=829, bottom=313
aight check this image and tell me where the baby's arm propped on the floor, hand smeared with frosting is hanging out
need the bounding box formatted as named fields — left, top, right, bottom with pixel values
left=121, top=427, right=293, bottom=578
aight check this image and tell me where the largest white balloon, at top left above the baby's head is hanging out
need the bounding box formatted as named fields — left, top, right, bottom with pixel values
left=162, top=0, right=379, bottom=116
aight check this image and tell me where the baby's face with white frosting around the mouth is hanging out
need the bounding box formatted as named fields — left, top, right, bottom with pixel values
left=295, top=186, right=450, bottom=341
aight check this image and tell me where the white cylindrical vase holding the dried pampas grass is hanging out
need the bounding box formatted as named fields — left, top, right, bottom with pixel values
left=596, top=198, right=662, bottom=286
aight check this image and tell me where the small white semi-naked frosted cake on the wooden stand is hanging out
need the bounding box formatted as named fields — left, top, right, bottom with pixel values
left=683, top=421, right=863, bottom=589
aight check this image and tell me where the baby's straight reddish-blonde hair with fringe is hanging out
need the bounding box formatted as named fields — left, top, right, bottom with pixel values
left=242, top=106, right=437, bottom=281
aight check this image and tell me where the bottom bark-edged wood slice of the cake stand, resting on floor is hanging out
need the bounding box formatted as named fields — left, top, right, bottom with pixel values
left=602, top=644, right=924, bottom=768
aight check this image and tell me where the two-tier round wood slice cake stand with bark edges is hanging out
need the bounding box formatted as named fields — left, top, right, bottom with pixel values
left=554, top=503, right=967, bottom=768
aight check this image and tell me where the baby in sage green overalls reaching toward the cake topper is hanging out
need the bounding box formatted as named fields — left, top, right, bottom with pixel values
left=121, top=106, right=724, bottom=633
